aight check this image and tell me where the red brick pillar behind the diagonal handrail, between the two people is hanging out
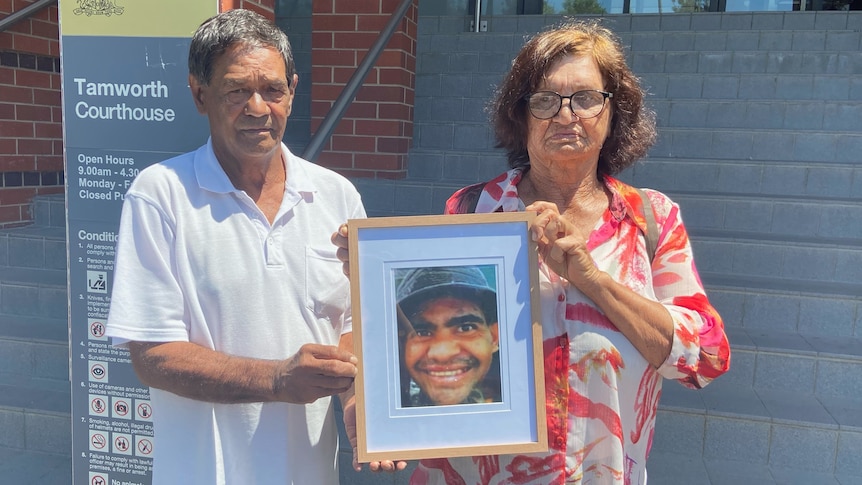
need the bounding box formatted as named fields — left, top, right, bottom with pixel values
left=311, top=0, right=417, bottom=179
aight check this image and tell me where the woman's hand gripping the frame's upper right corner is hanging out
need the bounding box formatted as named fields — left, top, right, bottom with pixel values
left=526, top=201, right=601, bottom=288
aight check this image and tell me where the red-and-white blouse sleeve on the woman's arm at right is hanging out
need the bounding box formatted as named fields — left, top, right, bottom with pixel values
left=648, top=191, right=730, bottom=389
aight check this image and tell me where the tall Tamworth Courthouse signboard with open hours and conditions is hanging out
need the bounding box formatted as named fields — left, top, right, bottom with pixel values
left=59, top=0, right=218, bottom=485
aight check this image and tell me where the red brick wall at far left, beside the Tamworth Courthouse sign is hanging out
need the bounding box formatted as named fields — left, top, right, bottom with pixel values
left=0, top=0, right=64, bottom=227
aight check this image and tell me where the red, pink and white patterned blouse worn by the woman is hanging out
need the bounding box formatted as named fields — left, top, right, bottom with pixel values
left=410, top=169, right=730, bottom=485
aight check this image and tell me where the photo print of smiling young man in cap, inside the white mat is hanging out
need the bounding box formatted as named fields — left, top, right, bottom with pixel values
left=396, top=266, right=501, bottom=407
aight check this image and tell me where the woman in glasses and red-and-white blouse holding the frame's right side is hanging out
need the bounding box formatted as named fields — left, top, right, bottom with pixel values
left=426, top=21, right=730, bottom=485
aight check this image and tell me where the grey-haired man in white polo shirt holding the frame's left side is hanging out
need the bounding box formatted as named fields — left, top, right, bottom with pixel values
left=107, top=10, right=376, bottom=485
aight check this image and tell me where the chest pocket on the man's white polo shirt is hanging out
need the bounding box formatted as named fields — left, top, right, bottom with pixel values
left=305, top=246, right=350, bottom=325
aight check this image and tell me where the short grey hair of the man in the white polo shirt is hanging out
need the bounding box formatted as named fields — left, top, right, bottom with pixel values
left=189, top=9, right=296, bottom=85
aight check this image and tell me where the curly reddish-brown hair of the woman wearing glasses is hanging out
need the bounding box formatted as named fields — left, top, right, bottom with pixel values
left=489, top=20, right=656, bottom=175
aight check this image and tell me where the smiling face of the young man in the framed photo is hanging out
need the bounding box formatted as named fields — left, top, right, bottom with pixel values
left=404, top=297, right=499, bottom=405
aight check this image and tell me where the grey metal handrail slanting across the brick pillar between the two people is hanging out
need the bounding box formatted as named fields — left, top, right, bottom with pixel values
left=302, top=0, right=413, bottom=162
